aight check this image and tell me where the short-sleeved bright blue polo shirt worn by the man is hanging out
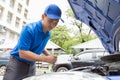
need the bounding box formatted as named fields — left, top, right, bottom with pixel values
left=10, top=21, right=51, bottom=63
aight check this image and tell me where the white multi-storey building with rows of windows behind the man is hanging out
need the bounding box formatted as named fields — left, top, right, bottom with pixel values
left=0, top=0, right=29, bottom=45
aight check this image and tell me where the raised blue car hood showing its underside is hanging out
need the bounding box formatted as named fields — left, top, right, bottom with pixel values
left=68, top=0, right=120, bottom=54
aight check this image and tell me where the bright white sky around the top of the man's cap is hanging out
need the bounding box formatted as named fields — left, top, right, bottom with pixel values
left=29, top=0, right=70, bottom=20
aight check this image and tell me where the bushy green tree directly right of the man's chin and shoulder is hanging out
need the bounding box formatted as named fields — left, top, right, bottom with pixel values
left=51, top=25, right=79, bottom=53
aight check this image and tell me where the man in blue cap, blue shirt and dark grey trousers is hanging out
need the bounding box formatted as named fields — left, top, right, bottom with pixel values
left=3, top=4, right=62, bottom=80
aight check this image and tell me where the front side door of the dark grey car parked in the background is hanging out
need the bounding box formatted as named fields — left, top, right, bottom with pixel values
left=71, top=52, right=96, bottom=68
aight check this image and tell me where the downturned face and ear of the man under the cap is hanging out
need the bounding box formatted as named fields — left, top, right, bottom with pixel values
left=43, top=15, right=59, bottom=31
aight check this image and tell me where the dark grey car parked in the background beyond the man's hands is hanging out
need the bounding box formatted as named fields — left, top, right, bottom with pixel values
left=52, top=49, right=109, bottom=72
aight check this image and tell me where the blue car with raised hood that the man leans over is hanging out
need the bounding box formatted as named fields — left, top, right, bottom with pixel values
left=25, top=0, right=120, bottom=80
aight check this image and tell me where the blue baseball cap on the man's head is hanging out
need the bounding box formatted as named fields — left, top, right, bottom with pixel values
left=44, top=4, right=62, bottom=19
